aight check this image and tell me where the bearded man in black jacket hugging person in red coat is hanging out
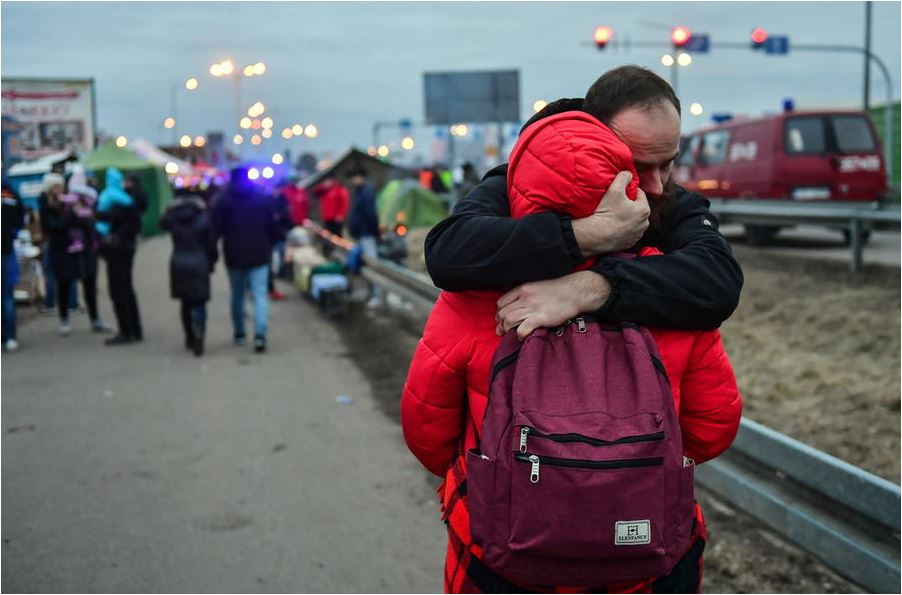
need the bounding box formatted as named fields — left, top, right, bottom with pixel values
left=426, top=66, right=743, bottom=338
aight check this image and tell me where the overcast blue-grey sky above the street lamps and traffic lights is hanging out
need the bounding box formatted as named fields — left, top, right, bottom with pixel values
left=0, top=1, right=900, bottom=163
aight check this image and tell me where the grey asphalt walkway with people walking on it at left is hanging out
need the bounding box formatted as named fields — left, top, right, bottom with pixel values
left=2, top=238, right=445, bottom=593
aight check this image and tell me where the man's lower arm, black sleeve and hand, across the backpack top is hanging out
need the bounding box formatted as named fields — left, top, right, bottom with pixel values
left=497, top=188, right=743, bottom=338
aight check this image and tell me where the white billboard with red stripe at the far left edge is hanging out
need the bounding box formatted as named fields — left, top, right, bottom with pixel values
left=2, top=78, right=95, bottom=163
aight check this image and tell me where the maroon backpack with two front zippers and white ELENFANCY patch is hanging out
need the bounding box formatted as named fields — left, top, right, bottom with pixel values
left=467, top=318, right=694, bottom=586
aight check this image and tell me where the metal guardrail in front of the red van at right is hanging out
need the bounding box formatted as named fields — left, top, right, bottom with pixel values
left=710, top=198, right=900, bottom=273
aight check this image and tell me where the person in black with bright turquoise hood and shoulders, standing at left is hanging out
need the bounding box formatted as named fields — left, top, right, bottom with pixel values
left=94, top=167, right=144, bottom=345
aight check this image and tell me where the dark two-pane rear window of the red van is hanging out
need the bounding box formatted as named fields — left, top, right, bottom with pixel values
left=784, top=115, right=877, bottom=155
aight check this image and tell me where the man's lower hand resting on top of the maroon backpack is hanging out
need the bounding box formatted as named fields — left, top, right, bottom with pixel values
left=495, top=271, right=611, bottom=341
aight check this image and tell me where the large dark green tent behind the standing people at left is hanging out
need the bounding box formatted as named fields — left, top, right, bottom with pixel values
left=80, top=142, right=172, bottom=236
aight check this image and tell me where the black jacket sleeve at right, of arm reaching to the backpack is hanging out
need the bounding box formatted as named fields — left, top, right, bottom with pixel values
left=595, top=188, right=743, bottom=330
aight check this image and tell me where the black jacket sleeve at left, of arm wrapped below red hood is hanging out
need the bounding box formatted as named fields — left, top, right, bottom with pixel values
left=425, top=166, right=580, bottom=291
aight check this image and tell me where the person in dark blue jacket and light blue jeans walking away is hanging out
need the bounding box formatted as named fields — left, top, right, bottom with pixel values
left=213, top=167, right=278, bottom=353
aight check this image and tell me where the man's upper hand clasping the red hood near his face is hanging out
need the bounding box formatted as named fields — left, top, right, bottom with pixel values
left=573, top=171, right=651, bottom=257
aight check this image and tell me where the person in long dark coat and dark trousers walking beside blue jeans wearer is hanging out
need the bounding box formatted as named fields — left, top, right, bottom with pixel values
left=160, top=189, right=217, bottom=357
